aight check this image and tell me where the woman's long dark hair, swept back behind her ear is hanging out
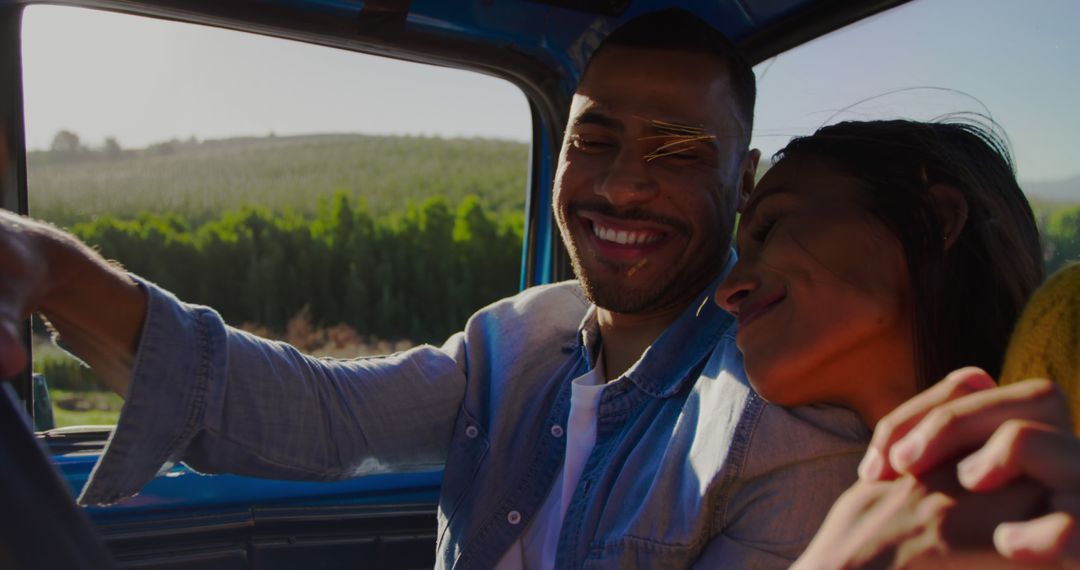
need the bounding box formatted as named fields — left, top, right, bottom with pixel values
left=775, top=121, right=1042, bottom=389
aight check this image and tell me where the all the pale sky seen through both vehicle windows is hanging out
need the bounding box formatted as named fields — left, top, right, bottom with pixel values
left=16, top=0, right=1080, bottom=180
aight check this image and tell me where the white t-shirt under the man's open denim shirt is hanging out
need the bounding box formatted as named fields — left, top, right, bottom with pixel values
left=495, top=355, right=607, bottom=570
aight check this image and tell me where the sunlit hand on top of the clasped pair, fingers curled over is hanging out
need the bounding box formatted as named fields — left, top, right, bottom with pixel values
left=855, top=368, right=1080, bottom=568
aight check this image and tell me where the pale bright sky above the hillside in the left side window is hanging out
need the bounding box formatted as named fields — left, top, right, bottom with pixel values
left=23, top=6, right=531, bottom=148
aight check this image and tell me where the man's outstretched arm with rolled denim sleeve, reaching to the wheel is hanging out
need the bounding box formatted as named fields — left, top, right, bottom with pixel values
left=0, top=213, right=465, bottom=504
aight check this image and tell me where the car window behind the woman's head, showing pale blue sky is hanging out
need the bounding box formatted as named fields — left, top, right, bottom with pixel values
left=752, top=0, right=1080, bottom=275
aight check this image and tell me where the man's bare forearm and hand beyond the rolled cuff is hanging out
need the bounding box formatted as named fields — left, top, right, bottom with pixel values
left=0, top=212, right=147, bottom=396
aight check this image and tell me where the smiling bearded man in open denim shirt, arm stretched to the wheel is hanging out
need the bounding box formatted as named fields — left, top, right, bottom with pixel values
left=0, top=12, right=868, bottom=568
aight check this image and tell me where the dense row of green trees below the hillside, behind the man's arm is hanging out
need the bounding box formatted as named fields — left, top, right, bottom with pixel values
left=70, top=188, right=524, bottom=343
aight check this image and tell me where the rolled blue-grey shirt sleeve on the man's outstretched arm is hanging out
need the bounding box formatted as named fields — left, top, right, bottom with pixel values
left=79, top=281, right=465, bottom=504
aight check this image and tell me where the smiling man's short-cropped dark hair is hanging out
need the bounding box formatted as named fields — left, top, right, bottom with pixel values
left=586, top=9, right=757, bottom=140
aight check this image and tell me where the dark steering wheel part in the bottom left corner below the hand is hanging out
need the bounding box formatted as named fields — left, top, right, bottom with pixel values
left=0, top=382, right=116, bottom=570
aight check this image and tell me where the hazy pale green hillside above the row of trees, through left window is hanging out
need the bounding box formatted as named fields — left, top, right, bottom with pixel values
left=27, top=135, right=528, bottom=226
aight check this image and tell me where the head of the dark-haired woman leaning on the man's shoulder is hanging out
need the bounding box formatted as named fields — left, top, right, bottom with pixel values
left=716, top=121, right=1042, bottom=426
